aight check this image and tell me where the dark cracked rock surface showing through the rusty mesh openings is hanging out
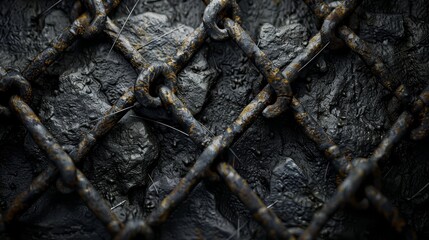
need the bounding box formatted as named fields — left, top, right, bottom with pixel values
left=0, top=0, right=429, bottom=239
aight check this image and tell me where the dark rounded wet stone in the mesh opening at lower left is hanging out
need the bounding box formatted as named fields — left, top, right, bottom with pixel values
left=88, top=111, right=159, bottom=217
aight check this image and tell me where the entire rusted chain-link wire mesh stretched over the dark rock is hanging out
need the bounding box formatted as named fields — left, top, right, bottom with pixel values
left=0, top=0, right=429, bottom=239
